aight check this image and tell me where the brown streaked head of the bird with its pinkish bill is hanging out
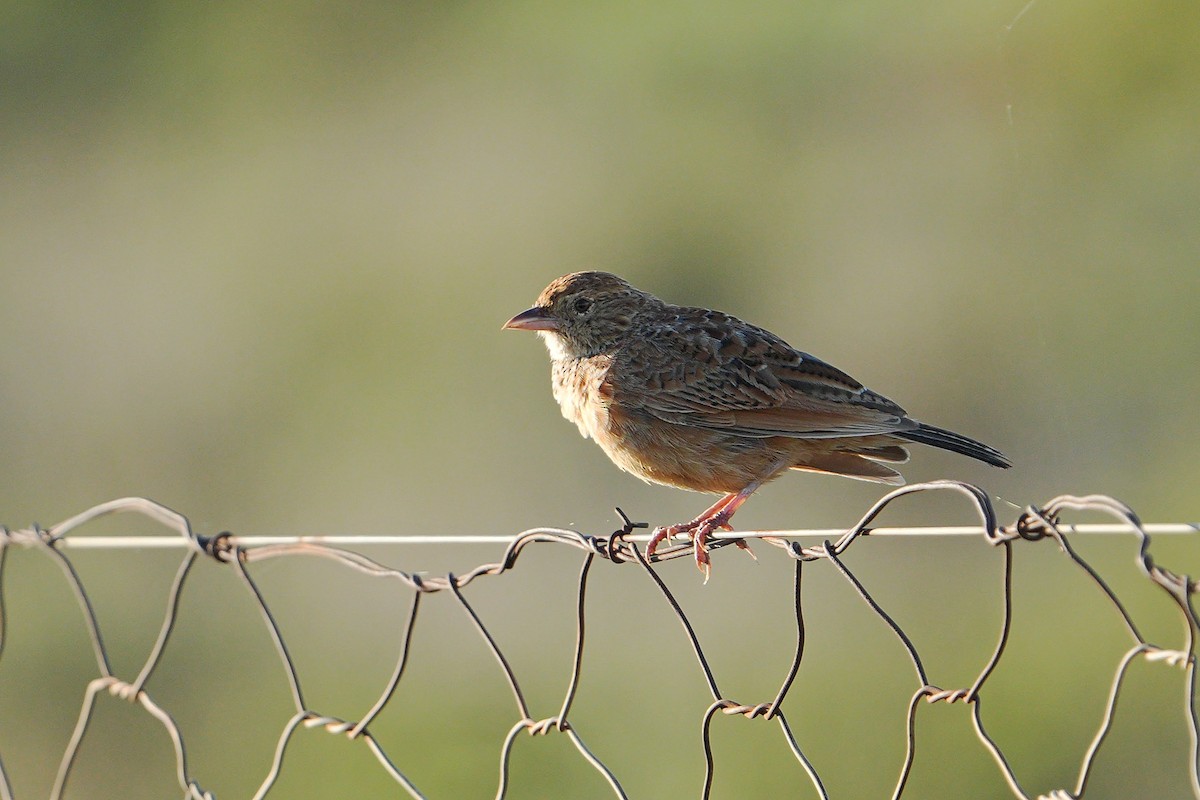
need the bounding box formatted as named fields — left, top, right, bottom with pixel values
left=504, top=272, right=664, bottom=360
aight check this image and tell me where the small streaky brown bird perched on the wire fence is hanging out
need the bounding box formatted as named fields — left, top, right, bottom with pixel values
left=504, top=272, right=1012, bottom=578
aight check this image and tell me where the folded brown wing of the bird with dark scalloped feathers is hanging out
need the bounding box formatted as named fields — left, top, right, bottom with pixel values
left=605, top=308, right=916, bottom=439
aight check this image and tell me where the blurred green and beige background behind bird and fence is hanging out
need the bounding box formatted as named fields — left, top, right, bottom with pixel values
left=0, top=0, right=1200, bottom=799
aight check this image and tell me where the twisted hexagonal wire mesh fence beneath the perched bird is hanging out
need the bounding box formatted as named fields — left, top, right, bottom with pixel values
left=0, top=481, right=1200, bottom=800
